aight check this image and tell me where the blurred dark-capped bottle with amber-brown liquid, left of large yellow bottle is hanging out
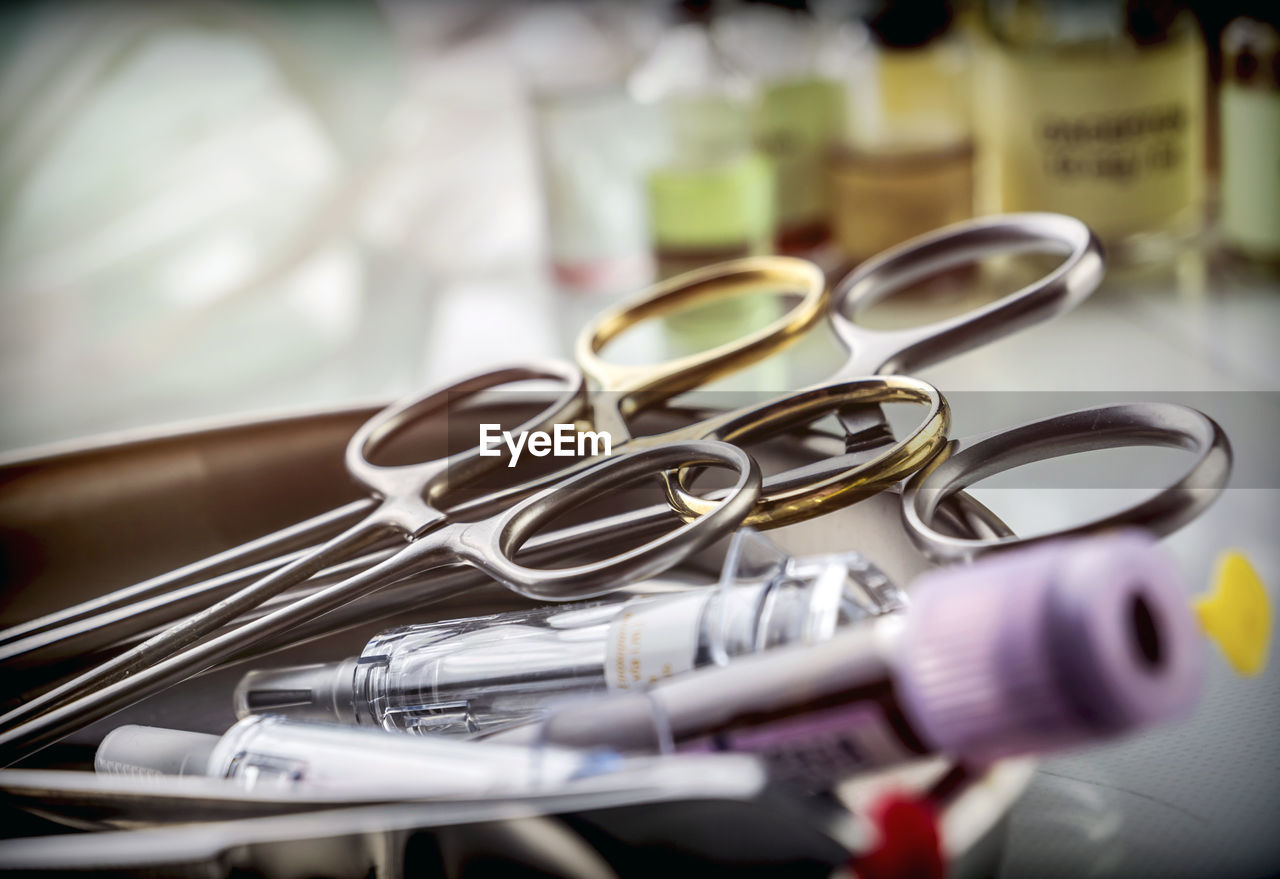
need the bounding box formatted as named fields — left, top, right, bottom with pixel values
left=831, top=0, right=973, bottom=268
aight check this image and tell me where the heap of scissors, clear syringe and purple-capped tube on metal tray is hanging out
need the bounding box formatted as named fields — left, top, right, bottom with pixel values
left=0, top=214, right=1230, bottom=875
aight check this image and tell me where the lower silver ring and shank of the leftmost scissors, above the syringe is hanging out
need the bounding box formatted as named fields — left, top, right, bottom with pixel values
left=0, top=440, right=760, bottom=761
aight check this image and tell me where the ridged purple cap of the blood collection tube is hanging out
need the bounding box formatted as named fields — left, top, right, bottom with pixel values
left=895, top=530, right=1203, bottom=764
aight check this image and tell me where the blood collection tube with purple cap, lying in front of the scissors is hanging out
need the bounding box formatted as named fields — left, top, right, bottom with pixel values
left=494, top=532, right=1203, bottom=786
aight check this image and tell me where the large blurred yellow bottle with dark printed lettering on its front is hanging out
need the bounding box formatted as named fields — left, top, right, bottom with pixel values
left=977, top=0, right=1206, bottom=264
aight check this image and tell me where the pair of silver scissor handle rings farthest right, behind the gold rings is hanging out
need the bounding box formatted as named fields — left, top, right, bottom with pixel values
left=668, top=214, right=1231, bottom=550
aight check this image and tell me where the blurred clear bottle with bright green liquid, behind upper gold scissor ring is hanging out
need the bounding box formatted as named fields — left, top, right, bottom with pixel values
left=631, top=0, right=785, bottom=389
